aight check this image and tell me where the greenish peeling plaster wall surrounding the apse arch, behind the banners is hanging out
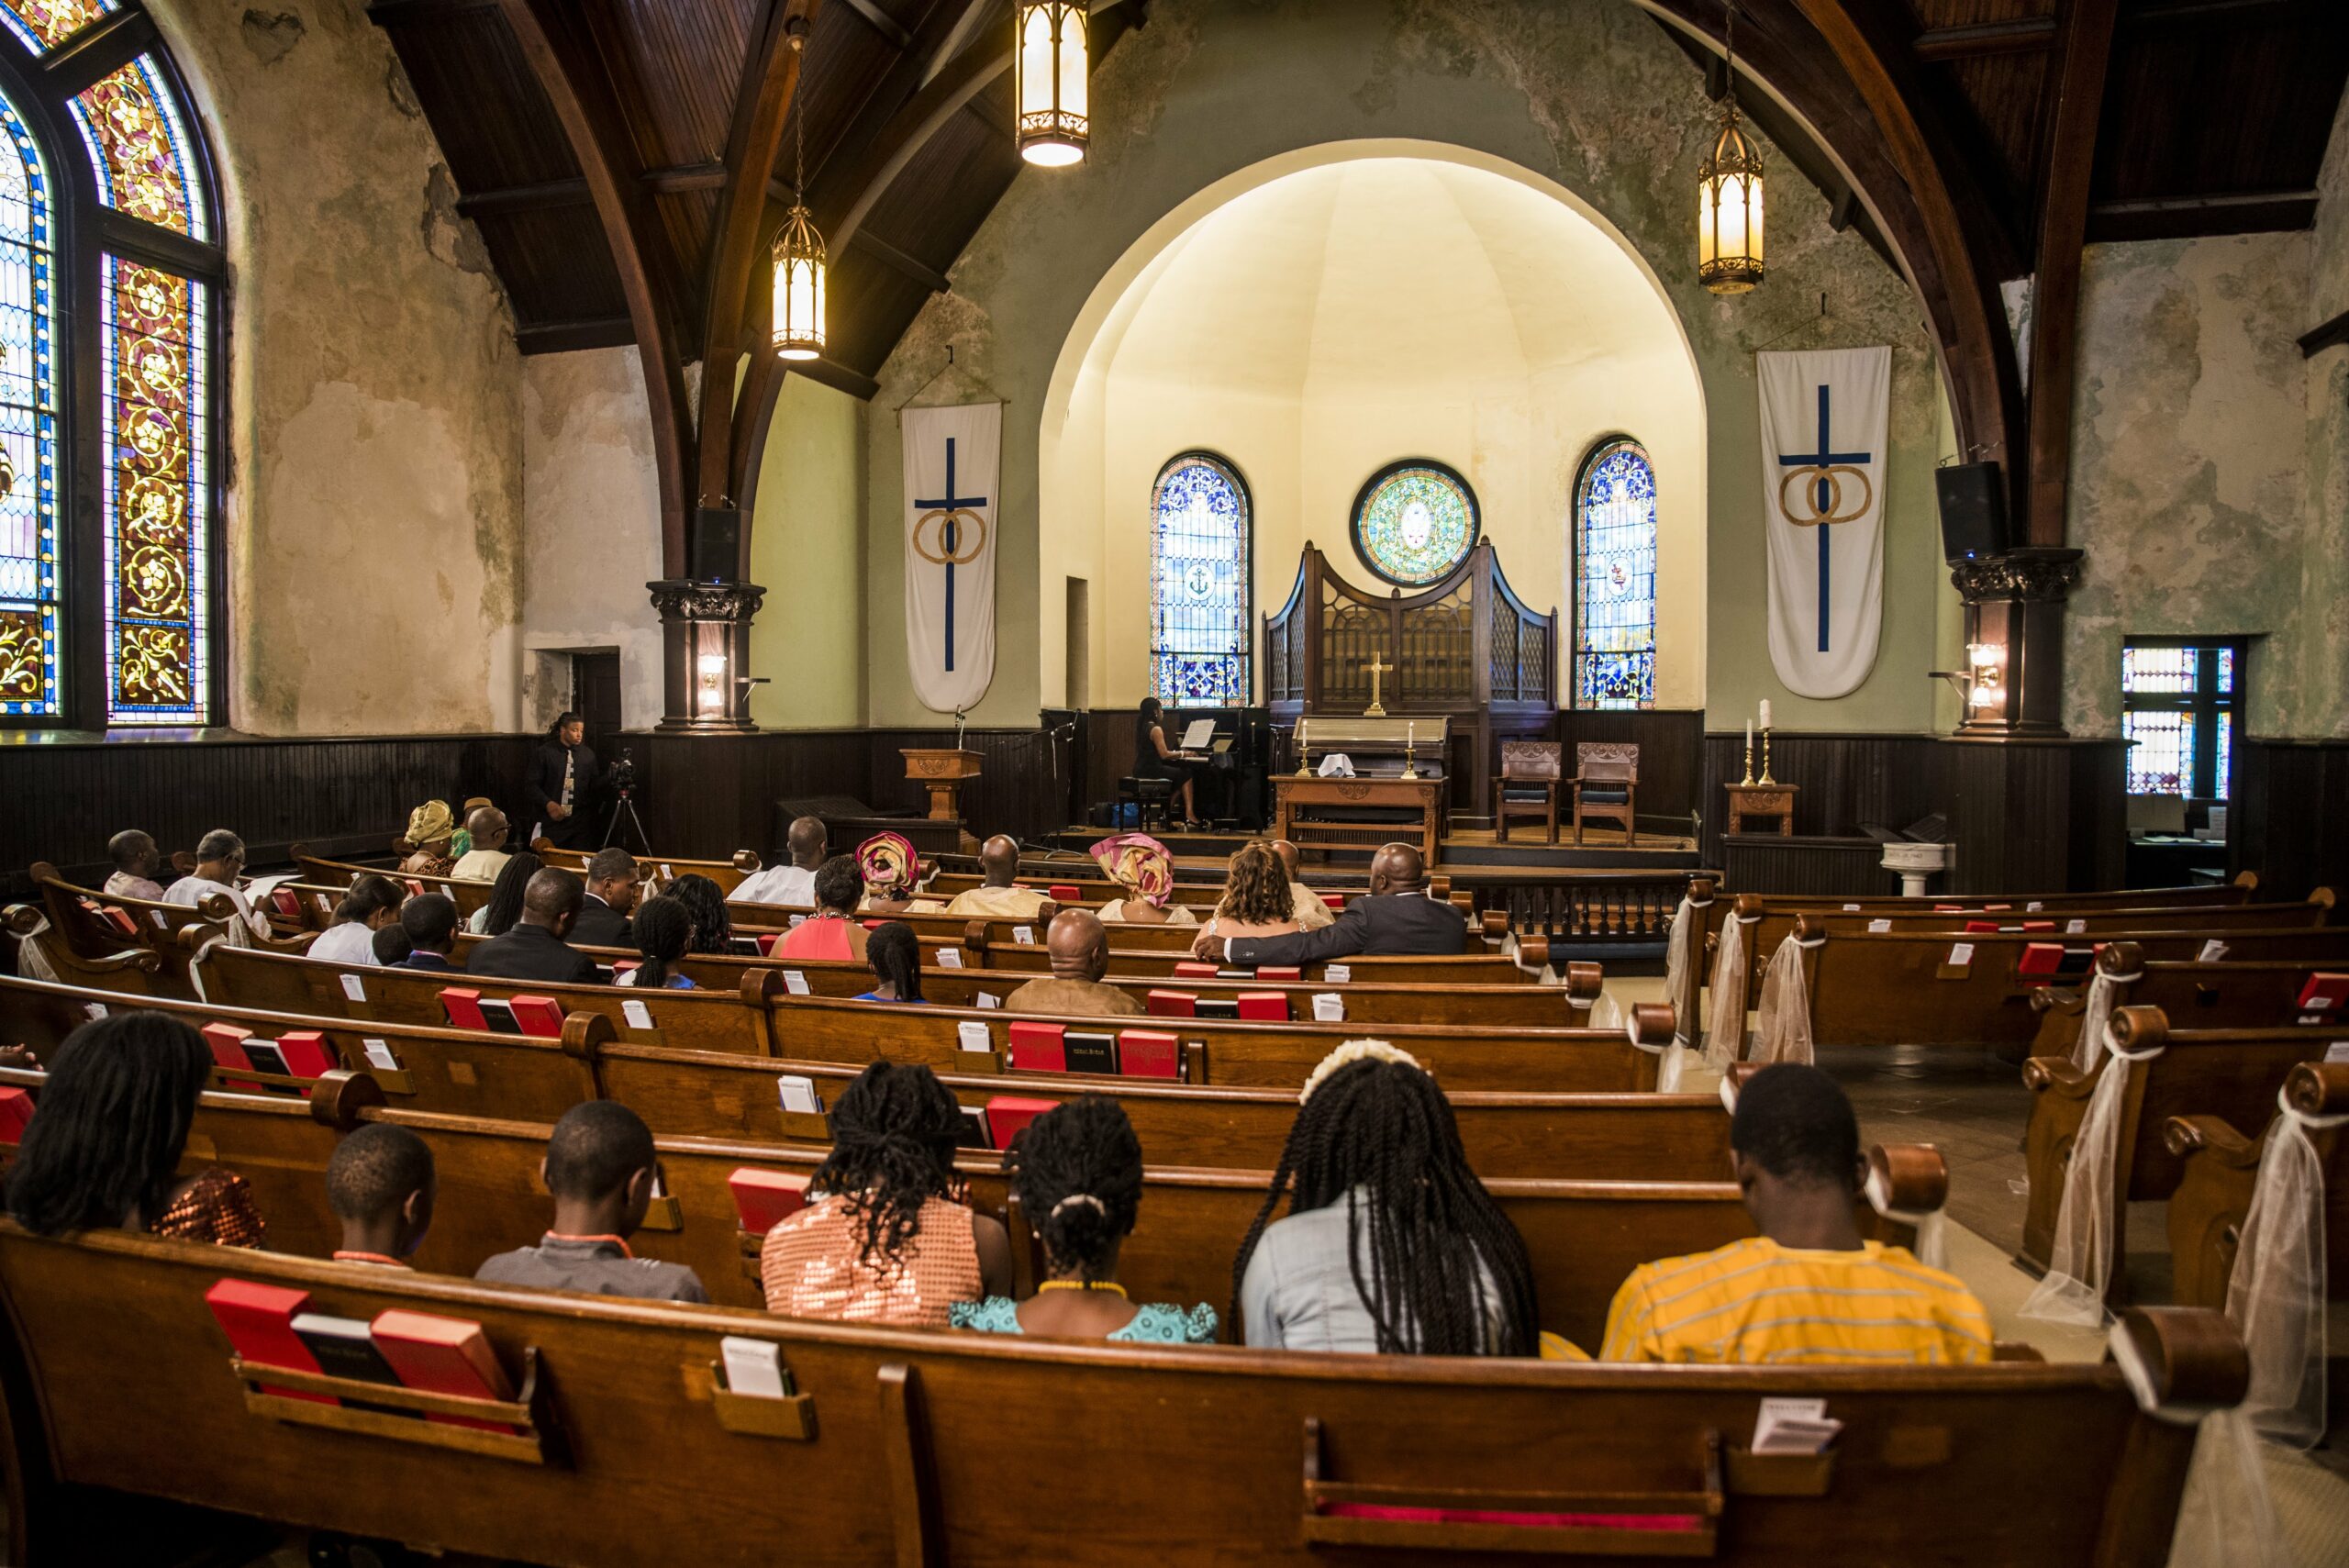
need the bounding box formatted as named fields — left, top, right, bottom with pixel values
left=864, top=0, right=1950, bottom=730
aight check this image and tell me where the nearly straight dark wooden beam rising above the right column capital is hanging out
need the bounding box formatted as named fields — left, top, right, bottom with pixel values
left=2022, top=0, right=2119, bottom=545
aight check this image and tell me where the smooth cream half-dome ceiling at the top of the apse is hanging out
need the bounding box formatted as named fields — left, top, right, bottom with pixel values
left=1107, top=157, right=1687, bottom=399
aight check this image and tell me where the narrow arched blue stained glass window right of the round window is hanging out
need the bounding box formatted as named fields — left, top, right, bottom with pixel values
left=1574, top=437, right=1656, bottom=709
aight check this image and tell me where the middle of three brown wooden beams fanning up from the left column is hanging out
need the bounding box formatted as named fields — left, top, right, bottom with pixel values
left=696, top=0, right=819, bottom=507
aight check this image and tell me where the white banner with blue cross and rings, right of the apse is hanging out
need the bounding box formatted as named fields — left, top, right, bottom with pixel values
left=1754, top=348, right=1893, bottom=697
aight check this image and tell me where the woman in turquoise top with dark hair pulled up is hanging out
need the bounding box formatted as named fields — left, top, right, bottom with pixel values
left=949, top=1094, right=1217, bottom=1345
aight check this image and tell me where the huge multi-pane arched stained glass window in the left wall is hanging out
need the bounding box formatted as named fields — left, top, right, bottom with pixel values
left=0, top=0, right=228, bottom=728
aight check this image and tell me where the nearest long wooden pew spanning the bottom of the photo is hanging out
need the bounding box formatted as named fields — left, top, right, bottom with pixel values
left=0, top=1225, right=2245, bottom=1568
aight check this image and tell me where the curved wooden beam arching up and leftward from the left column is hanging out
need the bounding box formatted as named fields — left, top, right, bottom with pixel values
left=498, top=0, right=693, bottom=577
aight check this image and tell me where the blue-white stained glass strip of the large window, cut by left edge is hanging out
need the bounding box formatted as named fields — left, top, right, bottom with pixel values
left=0, top=88, right=59, bottom=716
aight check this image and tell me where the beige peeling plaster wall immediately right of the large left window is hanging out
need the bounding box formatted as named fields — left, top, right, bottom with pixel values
left=150, top=0, right=524, bottom=735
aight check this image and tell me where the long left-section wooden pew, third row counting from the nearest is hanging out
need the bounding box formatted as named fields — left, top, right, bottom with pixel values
left=0, top=979, right=1729, bottom=1181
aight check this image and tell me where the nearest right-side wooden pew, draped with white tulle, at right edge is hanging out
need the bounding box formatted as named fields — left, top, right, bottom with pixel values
left=2161, top=1061, right=2349, bottom=1312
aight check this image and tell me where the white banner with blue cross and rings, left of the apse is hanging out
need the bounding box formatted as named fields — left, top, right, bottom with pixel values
left=897, top=404, right=1003, bottom=714
